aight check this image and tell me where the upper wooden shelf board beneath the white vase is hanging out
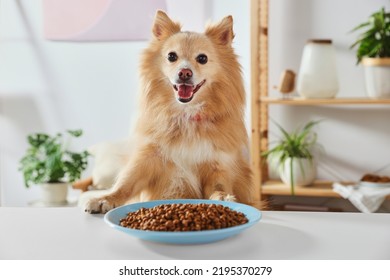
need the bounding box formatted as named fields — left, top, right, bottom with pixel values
left=260, top=96, right=390, bottom=105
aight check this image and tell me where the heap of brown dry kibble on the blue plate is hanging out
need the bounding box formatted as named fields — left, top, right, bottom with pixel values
left=120, top=203, right=248, bottom=231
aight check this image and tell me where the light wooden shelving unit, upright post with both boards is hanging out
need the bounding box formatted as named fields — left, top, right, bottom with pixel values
left=251, top=0, right=390, bottom=203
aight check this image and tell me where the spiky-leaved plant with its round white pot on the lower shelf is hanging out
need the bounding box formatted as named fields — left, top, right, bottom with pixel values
left=262, top=121, right=318, bottom=195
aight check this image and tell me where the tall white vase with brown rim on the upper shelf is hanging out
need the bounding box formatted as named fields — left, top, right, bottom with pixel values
left=297, top=40, right=339, bottom=98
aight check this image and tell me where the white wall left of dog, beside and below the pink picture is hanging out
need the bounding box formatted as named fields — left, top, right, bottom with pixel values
left=0, top=0, right=146, bottom=206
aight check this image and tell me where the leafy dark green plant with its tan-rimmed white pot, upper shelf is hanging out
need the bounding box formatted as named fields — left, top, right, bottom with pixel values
left=351, top=8, right=390, bottom=98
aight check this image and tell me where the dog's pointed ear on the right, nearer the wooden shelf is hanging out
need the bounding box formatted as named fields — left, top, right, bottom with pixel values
left=205, top=16, right=234, bottom=45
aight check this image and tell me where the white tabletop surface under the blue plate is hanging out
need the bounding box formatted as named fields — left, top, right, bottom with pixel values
left=0, top=207, right=390, bottom=260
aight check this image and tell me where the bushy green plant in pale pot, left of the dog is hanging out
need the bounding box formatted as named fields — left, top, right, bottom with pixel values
left=19, top=130, right=89, bottom=204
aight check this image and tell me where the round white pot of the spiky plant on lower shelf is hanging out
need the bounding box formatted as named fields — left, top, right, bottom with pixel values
left=279, top=158, right=317, bottom=186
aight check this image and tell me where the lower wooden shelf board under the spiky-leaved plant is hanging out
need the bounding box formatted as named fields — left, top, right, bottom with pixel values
left=261, top=180, right=341, bottom=197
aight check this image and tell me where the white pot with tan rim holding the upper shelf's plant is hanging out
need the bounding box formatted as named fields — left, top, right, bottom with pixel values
left=362, top=57, right=390, bottom=99
